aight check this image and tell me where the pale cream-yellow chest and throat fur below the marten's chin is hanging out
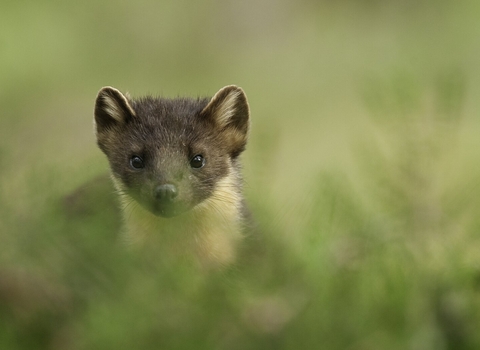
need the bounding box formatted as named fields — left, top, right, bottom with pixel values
left=115, top=176, right=243, bottom=268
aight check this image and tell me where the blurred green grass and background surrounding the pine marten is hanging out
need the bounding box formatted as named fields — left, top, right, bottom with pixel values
left=0, top=0, right=480, bottom=350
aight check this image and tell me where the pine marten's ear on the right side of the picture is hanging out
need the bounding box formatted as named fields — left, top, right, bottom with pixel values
left=200, top=85, right=250, bottom=153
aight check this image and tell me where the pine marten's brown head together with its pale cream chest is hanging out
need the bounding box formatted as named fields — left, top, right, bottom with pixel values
left=94, top=86, right=250, bottom=264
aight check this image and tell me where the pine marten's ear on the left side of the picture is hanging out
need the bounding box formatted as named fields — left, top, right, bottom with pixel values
left=94, top=86, right=135, bottom=133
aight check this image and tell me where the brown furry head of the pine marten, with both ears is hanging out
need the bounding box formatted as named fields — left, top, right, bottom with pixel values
left=95, top=86, right=250, bottom=217
